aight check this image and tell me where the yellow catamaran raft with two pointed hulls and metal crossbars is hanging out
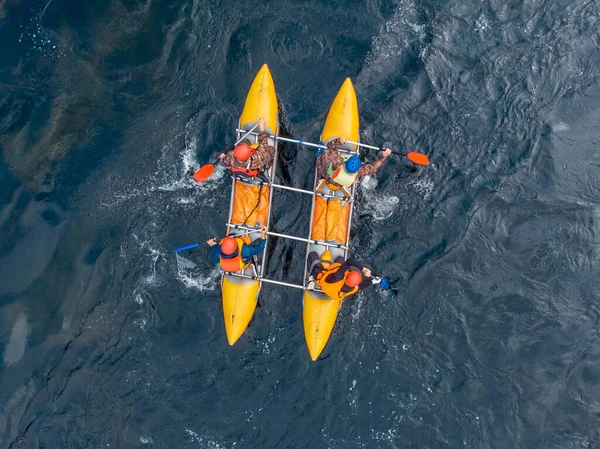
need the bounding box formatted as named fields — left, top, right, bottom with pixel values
left=222, top=77, right=359, bottom=360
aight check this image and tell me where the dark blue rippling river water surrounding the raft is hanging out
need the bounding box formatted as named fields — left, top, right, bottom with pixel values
left=0, top=0, right=600, bottom=449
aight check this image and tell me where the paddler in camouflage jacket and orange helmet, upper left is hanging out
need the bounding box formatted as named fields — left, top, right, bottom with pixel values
left=219, top=117, right=275, bottom=178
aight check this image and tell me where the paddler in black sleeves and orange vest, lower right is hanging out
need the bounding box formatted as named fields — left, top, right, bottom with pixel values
left=308, top=251, right=373, bottom=299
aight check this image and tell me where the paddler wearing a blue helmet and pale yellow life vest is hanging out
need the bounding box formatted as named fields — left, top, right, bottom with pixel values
left=317, top=137, right=392, bottom=194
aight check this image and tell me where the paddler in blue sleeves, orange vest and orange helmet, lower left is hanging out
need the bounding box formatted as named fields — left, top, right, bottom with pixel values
left=206, top=228, right=267, bottom=273
